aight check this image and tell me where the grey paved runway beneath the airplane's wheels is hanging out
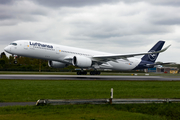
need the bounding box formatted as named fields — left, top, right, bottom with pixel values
left=0, top=75, right=180, bottom=81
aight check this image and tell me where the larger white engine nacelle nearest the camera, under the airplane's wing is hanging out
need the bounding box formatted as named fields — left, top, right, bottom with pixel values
left=72, top=56, right=92, bottom=68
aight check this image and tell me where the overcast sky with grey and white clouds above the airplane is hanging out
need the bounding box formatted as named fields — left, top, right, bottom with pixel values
left=0, top=0, right=180, bottom=63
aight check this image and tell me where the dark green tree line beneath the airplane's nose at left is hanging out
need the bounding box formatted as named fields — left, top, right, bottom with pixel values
left=0, top=52, right=75, bottom=72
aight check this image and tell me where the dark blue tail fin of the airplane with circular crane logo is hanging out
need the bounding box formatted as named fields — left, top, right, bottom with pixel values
left=141, top=41, right=165, bottom=63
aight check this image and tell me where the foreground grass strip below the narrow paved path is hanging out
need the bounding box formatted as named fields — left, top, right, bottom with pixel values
left=0, top=103, right=180, bottom=120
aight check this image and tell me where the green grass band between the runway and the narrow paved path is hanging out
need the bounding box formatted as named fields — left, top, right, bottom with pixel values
left=0, top=80, right=180, bottom=102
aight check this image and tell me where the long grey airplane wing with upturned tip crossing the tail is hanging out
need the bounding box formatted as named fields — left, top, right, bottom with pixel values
left=92, top=45, right=171, bottom=62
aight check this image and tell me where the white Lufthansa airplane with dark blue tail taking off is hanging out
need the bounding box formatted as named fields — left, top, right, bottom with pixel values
left=4, top=40, right=171, bottom=75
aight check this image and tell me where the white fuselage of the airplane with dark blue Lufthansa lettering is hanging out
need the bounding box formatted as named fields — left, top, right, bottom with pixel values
left=5, top=40, right=141, bottom=70
